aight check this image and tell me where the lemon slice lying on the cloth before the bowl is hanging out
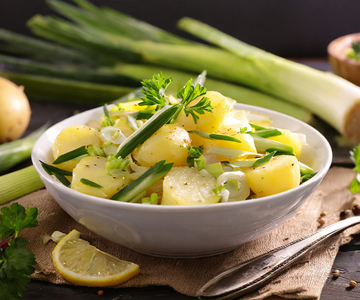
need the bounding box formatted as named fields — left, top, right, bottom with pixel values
left=52, top=230, right=139, bottom=287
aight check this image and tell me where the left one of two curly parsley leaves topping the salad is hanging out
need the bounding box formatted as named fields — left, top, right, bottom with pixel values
left=139, top=73, right=172, bottom=111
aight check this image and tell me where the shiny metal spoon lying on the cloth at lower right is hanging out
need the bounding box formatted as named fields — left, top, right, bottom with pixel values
left=197, top=216, right=360, bottom=300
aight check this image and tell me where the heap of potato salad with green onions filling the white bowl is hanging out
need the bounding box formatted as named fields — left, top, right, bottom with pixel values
left=41, top=74, right=315, bottom=205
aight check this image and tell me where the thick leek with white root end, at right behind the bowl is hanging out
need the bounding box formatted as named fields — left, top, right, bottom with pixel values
left=179, top=18, right=360, bottom=144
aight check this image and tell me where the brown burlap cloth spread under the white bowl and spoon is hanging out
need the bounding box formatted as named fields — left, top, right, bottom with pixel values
left=1, top=168, right=360, bottom=299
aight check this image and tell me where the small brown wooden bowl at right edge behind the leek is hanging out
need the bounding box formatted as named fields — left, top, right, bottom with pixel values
left=327, top=33, right=360, bottom=86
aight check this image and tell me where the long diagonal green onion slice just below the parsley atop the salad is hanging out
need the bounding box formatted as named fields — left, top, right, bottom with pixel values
left=115, top=105, right=178, bottom=157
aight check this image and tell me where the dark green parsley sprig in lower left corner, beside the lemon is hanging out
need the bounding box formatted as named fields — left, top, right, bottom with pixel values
left=0, top=203, right=38, bottom=300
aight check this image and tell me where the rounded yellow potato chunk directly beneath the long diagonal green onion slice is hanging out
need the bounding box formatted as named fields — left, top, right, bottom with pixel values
left=133, top=124, right=191, bottom=167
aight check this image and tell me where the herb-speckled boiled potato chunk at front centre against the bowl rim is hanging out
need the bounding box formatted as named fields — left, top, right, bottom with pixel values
left=161, top=167, right=221, bottom=205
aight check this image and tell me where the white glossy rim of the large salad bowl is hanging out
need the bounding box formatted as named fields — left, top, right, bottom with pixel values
left=31, top=103, right=332, bottom=213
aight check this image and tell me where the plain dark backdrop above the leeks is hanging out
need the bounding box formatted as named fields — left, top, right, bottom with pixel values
left=0, top=0, right=360, bottom=57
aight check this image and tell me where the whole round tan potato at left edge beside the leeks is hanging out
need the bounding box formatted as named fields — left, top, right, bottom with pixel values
left=0, top=77, right=31, bottom=144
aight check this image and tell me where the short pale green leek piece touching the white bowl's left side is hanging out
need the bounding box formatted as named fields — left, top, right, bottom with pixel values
left=0, top=166, right=44, bottom=205
